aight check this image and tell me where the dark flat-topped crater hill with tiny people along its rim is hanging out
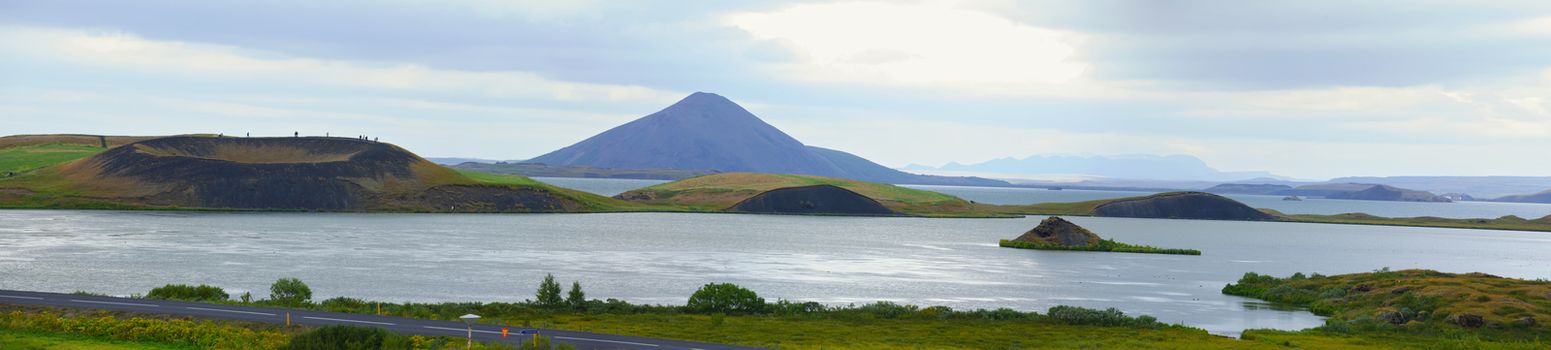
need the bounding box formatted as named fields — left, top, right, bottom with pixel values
left=59, top=136, right=583, bottom=211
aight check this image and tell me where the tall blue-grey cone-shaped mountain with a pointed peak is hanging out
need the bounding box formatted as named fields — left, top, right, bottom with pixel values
left=526, top=93, right=1007, bottom=186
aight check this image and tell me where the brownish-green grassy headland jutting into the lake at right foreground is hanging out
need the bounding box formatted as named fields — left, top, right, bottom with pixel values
left=1222, top=268, right=1551, bottom=348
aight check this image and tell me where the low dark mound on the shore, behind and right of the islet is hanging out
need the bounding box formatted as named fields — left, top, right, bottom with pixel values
left=1093, top=192, right=1275, bottom=220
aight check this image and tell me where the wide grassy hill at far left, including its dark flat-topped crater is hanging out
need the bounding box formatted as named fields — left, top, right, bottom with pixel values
left=0, top=135, right=651, bottom=212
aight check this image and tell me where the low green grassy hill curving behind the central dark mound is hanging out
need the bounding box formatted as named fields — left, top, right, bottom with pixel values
left=614, top=172, right=996, bottom=217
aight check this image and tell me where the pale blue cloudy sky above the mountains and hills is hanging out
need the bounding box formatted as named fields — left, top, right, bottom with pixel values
left=0, top=0, right=1551, bottom=180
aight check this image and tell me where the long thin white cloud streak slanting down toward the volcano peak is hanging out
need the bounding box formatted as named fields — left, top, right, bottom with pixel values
left=0, top=26, right=684, bottom=102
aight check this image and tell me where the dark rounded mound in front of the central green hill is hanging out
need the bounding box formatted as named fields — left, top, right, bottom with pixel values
left=729, top=184, right=896, bottom=215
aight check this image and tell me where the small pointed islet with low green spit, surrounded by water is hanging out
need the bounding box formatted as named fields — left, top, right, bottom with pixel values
left=999, top=217, right=1200, bottom=256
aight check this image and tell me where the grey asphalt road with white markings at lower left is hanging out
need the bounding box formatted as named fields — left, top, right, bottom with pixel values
left=0, top=290, right=763, bottom=350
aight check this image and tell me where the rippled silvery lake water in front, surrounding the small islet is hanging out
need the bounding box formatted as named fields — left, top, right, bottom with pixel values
left=9, top=211, right=1551, bottom=335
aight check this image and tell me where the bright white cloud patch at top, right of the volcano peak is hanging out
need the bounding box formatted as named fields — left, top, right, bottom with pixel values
left=724, top=2, right=1089, bottom=93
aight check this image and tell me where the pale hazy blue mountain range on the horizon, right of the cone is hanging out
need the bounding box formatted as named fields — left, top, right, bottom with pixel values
left=904, top=155, right=1286, bottom=181
